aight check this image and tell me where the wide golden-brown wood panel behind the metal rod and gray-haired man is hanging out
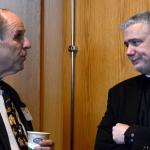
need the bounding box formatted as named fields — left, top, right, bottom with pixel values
left=64, top=0, right=150, bottom=150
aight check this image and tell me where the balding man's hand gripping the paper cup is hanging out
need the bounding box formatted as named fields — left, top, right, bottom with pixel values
left=34, top=139, right=54, bottom=150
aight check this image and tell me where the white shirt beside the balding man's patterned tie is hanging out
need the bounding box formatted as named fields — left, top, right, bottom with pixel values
left=0, top=93, right=19, bottom=150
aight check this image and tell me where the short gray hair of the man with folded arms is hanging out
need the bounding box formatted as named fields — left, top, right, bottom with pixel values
left=121, top=11, right=150, bottom=30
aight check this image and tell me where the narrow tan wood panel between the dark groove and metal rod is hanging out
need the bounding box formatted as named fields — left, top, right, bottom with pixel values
left=42, top=0, right=64, bottom=150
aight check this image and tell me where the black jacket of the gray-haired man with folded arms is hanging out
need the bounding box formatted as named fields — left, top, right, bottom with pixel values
left=95, top=75, right=150, bottom=150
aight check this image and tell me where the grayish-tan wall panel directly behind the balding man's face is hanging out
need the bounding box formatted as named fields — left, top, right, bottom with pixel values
left=0, top=0, right=40, bottom=130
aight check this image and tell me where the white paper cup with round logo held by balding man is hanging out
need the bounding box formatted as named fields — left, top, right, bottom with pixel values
left=27, top=131, right=50, bottom=150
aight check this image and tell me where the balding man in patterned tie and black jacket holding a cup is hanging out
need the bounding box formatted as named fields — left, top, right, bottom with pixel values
left=0, top=9, right=54, bottom=150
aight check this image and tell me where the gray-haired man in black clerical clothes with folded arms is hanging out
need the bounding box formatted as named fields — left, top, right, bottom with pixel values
left=95, top=11, right=150, bottom=150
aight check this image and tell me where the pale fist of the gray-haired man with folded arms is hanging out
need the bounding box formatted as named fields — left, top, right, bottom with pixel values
left=112, top=123, right=129, bottom=144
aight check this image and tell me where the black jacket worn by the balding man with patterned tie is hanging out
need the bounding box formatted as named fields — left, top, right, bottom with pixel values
left=0, top=81, right=33, bottom=150
